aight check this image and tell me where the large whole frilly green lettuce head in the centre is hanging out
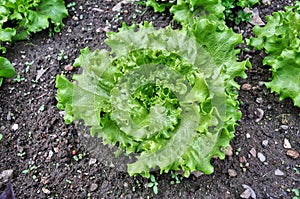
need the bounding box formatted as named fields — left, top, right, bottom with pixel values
left=56, top=19, right=249, bottom=177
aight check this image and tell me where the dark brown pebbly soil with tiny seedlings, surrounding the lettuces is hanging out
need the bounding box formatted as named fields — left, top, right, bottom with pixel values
left=0, top=0, right=300, bottom=199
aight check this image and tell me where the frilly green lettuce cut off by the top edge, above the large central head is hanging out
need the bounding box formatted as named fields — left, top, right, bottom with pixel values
left=146, top=0, right=259, bottom=24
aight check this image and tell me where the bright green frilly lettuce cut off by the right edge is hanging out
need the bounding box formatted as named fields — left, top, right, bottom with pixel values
left=249, top=1, right=300, bottom=107
